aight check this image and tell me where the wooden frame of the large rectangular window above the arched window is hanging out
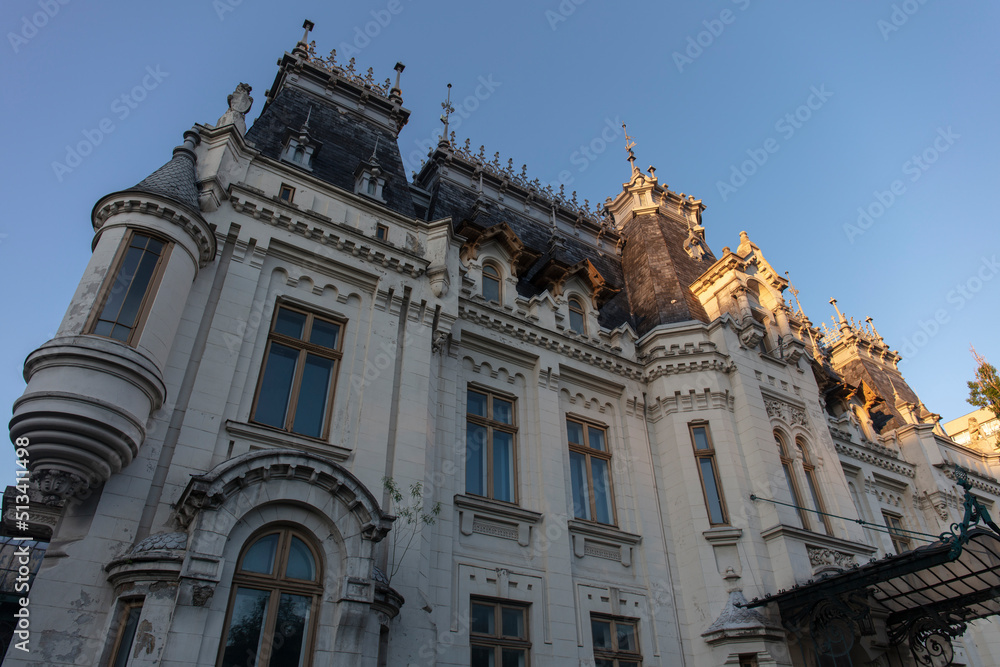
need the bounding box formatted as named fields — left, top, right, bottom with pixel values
left=250, top=300, right=347, bottom=442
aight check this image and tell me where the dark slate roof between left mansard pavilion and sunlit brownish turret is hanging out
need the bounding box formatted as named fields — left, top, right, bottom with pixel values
left=427, top=179, right=634, bottom=329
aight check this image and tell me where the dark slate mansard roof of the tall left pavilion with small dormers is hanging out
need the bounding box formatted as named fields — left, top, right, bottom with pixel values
left=246, top=87, right=414, bottom=218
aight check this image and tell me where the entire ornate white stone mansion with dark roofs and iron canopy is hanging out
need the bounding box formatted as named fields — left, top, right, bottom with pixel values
left=4, top=22, right=1000, bottom=667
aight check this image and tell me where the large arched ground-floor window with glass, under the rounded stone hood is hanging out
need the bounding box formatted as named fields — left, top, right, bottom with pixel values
left=218, top=526, right=323, bottom=667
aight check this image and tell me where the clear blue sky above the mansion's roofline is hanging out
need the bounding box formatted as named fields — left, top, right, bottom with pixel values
left=0, top=0, right=1000, bottom=483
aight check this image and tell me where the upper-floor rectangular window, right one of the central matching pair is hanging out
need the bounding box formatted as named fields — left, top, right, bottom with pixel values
left=566, top=417, right=617, bottom=525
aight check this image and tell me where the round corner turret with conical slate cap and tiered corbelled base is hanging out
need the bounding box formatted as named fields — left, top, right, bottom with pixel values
left=10, top=131, right=216, bottom=502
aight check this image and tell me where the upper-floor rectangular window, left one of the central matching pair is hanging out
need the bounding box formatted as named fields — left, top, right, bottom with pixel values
left=465, top=388, right=517, bottom=503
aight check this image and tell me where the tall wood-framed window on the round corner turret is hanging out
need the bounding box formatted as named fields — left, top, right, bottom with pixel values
left=88, top=232, right=170, bottom=345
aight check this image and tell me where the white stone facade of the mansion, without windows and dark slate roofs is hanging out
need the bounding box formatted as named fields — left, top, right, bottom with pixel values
left=6, top=27, right=1000, bottom=667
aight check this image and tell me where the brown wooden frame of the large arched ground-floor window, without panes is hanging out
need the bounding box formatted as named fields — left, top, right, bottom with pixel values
left=215, top=523, right=325, bottom=667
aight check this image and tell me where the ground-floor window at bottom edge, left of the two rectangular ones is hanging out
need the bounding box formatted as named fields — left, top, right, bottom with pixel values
left=469, top=598, right=531, bottom=667
